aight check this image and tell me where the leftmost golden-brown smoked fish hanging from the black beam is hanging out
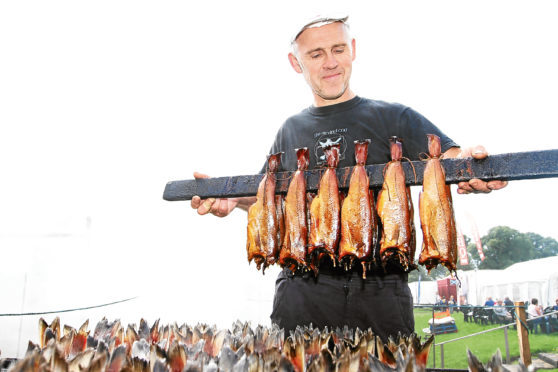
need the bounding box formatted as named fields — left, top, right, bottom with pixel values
left=246, top=153, right=284, bottom=272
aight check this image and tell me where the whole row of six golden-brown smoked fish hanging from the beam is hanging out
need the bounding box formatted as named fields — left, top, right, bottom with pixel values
left=246, top=134, right=457, bottom=277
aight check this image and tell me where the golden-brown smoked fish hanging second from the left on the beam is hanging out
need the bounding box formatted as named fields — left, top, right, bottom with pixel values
left=279, top=147, right=309, bottom=272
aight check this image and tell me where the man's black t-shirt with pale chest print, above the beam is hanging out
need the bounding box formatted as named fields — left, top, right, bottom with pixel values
left=262, top=96, right=458, bottom=172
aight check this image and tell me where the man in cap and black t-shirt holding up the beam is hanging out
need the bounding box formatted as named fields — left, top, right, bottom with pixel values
left=192, top=17, right=506, bottom=341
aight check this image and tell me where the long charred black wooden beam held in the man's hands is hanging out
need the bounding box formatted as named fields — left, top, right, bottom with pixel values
left=163, top=149, right=558, bottom=201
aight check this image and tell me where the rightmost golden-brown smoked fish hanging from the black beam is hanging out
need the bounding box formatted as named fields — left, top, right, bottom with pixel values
left=419, top=134, right=457, bottom=273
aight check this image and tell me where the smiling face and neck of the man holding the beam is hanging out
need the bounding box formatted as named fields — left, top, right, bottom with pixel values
left=289, top=22, right=355, bottom=106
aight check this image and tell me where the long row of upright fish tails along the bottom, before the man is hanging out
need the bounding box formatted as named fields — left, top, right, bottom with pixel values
left=9, top=318, right=440, bottom=372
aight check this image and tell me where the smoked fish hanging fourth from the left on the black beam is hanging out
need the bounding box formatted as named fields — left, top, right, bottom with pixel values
left=339, top=140, right=377, bottom=277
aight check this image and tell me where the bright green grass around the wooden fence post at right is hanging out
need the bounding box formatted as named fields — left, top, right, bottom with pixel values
left=415, top=309, right=558, bottom=371
